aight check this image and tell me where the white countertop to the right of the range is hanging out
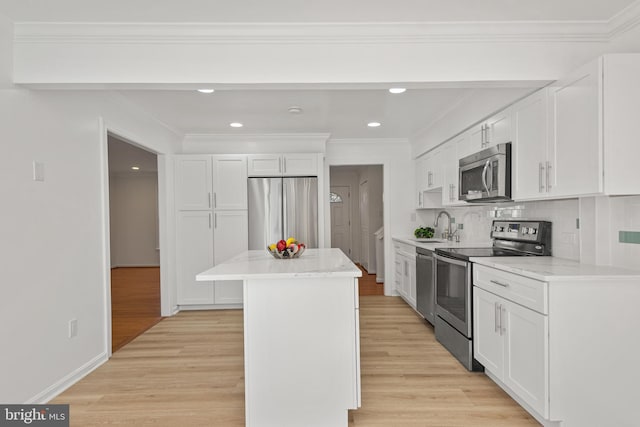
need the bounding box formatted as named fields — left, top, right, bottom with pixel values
left=471, top=256, right=640, bottom=281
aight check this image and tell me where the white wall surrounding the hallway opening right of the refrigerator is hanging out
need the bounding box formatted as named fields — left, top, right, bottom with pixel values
left=325, top=140, right=415, bottom=295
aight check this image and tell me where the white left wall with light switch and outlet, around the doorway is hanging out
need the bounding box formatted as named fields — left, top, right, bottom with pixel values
left=0, top=15, right=179, bottom=403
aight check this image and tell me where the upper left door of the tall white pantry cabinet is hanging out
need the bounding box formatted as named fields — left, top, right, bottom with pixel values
left=175, top=155, right=213, bottom=211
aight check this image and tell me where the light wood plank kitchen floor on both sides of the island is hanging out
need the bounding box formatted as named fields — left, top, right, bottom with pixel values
left=52, top=296, right=538, bottom=427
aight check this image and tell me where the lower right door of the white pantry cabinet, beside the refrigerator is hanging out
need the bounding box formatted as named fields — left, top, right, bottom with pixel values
left=212, top=210, right=249, bottom=304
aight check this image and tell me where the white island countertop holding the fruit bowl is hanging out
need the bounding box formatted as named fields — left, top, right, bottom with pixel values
left=196, top=248, right=362, bottom=281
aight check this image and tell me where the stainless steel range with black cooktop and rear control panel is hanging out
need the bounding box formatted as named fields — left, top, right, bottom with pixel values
left=434, top=221, right=551, bottom=371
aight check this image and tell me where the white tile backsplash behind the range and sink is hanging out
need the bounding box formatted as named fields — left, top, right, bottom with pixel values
left=416, top=199, right=584, bottom=260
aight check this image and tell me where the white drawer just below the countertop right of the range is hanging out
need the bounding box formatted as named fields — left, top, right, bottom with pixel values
left=473, top=264, right=549, bottom=314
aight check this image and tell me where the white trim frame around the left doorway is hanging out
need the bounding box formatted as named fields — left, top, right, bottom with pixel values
left=99, top=117, right=169, bottom=359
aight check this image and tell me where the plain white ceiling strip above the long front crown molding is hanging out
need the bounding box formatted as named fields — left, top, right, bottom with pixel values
left=0, top=0, right=633, bottom=22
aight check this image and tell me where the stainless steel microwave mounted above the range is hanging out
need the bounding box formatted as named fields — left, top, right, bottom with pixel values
left=458, top=142, right=511, bottom=203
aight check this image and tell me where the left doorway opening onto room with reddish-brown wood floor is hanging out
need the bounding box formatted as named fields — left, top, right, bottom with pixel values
left=107, top=133, right=162, bottom=352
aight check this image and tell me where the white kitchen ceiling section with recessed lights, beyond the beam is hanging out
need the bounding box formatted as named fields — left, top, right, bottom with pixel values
left=121, top=88, right=482, bottom=138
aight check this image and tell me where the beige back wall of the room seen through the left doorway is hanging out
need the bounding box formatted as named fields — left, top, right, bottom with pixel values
left=109, top=173, right=160, bottom=268
